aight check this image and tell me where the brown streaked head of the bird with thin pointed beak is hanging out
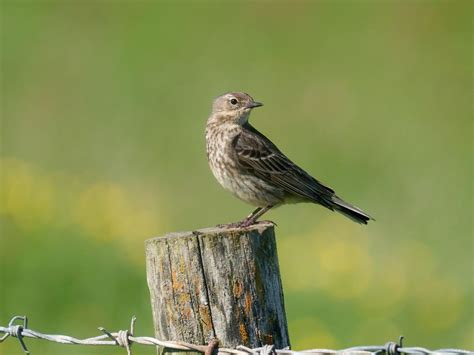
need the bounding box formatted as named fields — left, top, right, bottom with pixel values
left=212, top=92, right=263, bottom=125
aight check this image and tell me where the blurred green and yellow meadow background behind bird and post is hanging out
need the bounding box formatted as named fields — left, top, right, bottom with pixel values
left=0, top=0, right=474, bottom=354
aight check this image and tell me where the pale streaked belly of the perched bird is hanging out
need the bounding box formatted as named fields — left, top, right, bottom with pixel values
left=209, top=154, right=285, bottom=207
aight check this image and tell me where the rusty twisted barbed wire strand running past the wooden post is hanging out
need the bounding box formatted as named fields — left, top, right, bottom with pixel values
left=0, top=316, right=474, bottom=355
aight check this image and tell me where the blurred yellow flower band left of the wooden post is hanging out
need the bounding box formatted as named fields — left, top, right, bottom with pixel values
left=0, top=158, right=163, bottom=263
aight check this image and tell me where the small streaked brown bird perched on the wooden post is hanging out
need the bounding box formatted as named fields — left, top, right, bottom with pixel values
left=205, top=92, right=373, bottom=227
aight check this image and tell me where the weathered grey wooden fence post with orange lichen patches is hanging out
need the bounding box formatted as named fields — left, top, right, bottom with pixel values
left=146, top=223, right=290, bottom=349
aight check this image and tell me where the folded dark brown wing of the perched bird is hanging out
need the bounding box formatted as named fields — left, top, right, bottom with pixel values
left=233, top=124, right=334, bottom=209
